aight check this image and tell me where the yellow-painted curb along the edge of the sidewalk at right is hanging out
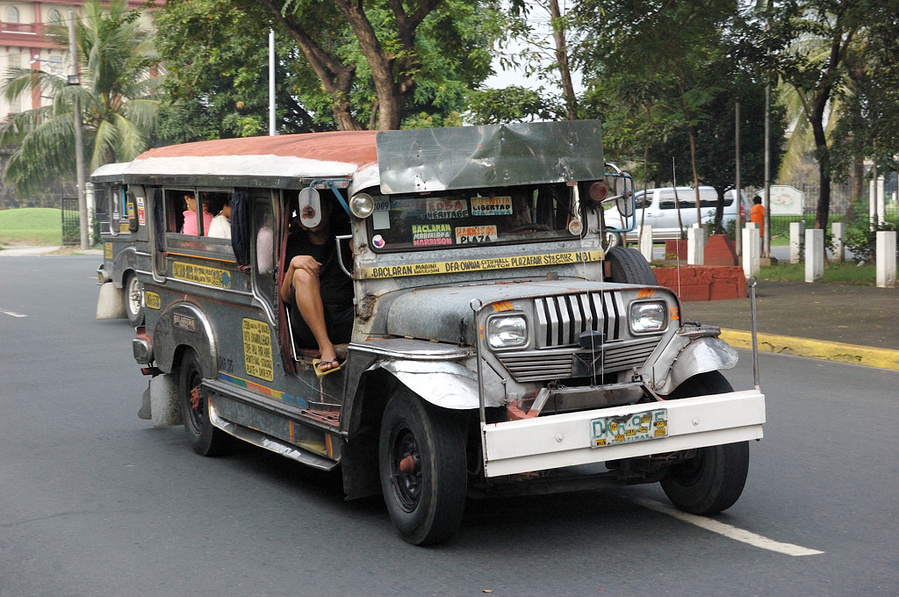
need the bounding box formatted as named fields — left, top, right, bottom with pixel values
left=721, top=329, right=899, bottom=371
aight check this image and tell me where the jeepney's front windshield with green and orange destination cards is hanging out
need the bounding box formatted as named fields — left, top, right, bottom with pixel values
left=368, top=184, right=581, bottom=252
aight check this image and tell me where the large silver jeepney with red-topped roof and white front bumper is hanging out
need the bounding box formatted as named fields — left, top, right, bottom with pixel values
left=105, top=121, right=765, bottom=544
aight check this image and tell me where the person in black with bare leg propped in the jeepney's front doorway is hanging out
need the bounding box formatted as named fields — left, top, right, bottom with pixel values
left=280, top=193, right=355, bottom=376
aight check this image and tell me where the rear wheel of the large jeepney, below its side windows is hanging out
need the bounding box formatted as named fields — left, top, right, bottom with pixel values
left=178, top=349, right=228, bottom=456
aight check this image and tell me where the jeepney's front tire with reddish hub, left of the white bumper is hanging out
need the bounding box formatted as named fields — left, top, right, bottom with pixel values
left=378, top=391, right=467, bottom=545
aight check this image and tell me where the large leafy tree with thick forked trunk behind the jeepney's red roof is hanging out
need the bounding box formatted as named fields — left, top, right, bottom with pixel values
left=160, top=0, right=502, bottom=137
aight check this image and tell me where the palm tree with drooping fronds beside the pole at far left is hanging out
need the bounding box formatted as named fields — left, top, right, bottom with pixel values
left=0, top=0, right=161, bottom=192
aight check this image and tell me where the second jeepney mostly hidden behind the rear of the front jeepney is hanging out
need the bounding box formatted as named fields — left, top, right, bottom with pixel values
left=91, top=162, right=150, bottom=325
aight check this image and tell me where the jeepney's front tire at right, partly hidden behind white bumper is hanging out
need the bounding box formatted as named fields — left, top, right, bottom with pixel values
left=661, top=371, right=749, bottom=516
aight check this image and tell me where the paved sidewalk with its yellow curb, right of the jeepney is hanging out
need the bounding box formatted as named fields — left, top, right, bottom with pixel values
left=682, top=281, right=899, bottom=370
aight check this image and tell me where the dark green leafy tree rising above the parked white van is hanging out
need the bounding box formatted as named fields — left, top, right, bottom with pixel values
left=578, top=0, right=738, bottom=210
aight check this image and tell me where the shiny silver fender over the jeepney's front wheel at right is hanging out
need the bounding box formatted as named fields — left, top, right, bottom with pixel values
left=652, top=325, right=739, bottom=396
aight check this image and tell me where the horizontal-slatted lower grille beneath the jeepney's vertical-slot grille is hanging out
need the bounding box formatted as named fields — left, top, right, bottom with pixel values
left=497, top=336, right=661, bottom=383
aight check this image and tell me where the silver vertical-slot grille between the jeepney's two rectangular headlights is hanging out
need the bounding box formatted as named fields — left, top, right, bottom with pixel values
left=534, top=291, right=626, bottom=348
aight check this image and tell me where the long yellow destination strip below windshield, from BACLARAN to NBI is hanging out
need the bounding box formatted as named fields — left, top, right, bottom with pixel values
left=361, top=251, right=603, bottom=280
